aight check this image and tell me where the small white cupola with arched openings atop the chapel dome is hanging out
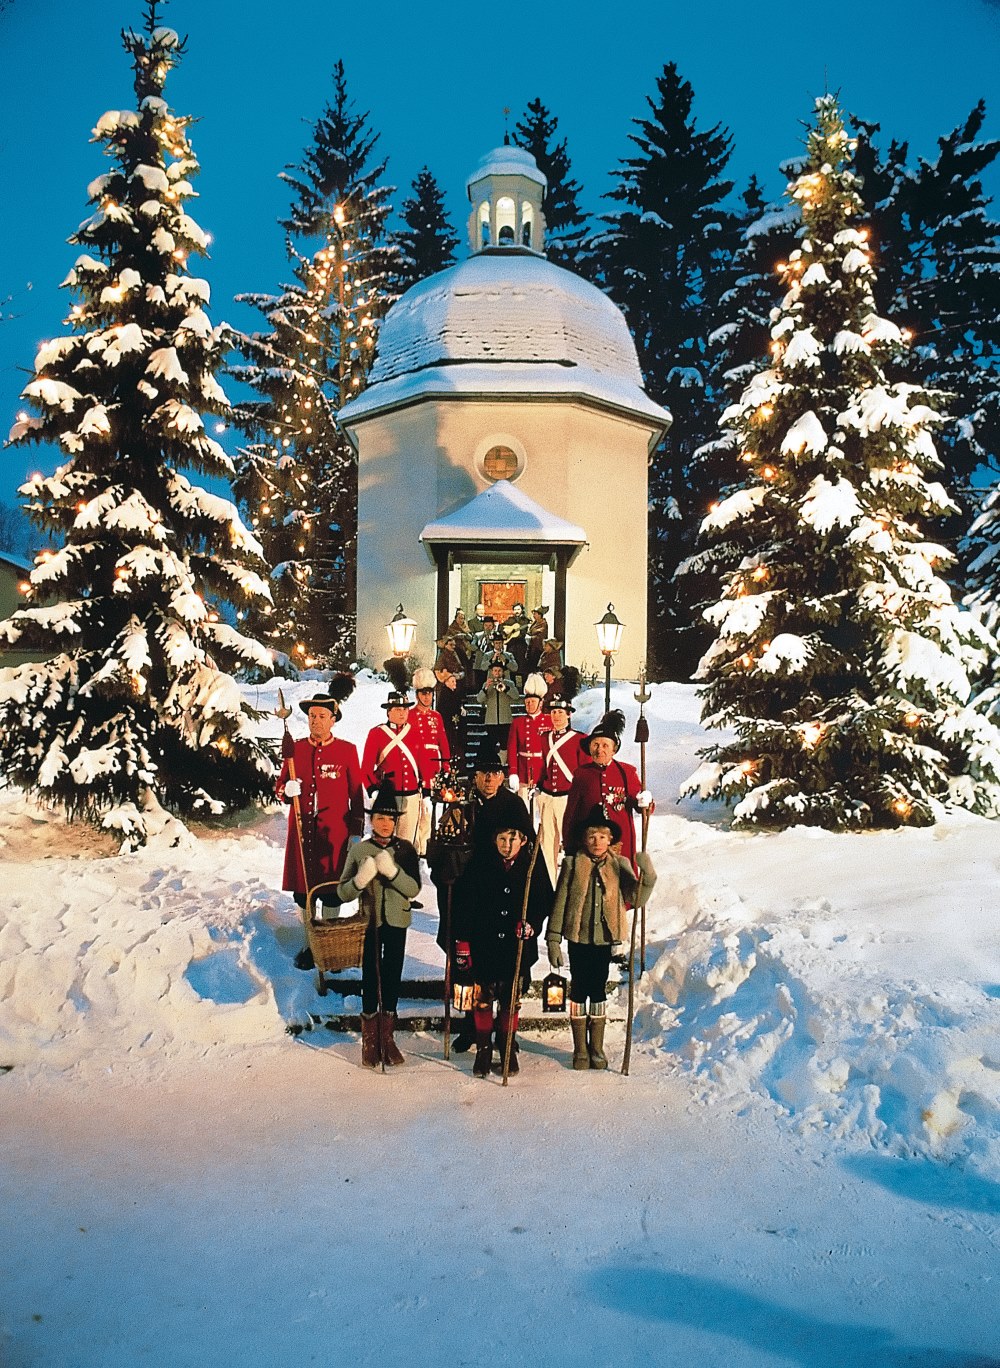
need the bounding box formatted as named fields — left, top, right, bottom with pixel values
left=465, top=145, right=547, bottom=252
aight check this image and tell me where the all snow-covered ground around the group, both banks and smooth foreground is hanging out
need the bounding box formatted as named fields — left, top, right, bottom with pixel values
left=0, top=680, right=1000, bottom=1368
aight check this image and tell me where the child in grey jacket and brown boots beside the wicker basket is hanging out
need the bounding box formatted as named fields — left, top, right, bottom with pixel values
left=337, top=778, right=420, bottom=1068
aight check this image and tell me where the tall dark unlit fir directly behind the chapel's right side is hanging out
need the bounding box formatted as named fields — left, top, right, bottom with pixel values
left=588, top=63, right=739, bottom=679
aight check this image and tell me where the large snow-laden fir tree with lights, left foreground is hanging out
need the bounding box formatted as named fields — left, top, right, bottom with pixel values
left=0, top=0, right=274, bottom=844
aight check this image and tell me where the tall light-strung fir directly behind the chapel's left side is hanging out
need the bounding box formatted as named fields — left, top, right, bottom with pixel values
left=233, top=62, right=398, bottom=665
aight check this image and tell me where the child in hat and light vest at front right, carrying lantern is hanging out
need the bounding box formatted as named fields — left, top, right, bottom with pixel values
left=546, top=804, right=657, bottom=1070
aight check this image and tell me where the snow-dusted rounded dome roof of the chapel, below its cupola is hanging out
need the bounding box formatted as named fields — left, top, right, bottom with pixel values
left=369, top=248, right=643, bottom=390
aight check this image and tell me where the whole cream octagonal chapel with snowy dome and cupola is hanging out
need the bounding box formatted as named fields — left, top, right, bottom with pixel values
left=339, top=146, right=670, bottom=677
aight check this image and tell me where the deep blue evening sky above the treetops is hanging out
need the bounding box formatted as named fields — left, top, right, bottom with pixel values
left=0, top=0, right=1000, bottom=511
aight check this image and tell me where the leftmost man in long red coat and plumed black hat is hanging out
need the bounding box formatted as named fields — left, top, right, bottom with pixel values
left=278, top=674, right=364, bottom=969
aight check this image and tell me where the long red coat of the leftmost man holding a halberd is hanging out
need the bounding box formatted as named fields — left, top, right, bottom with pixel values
left=278, top=736, right=364, bottom=893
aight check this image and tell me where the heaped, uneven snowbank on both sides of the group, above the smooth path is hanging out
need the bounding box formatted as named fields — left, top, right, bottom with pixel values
left=0, top=673, right=1000, bottom=1175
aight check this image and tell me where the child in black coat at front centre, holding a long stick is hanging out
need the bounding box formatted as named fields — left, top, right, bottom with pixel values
left=454, top=819, right=553, bottom=1078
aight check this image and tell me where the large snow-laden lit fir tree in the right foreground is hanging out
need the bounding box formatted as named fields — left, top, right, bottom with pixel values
left=688, top=96, right=1000, bottom=828
